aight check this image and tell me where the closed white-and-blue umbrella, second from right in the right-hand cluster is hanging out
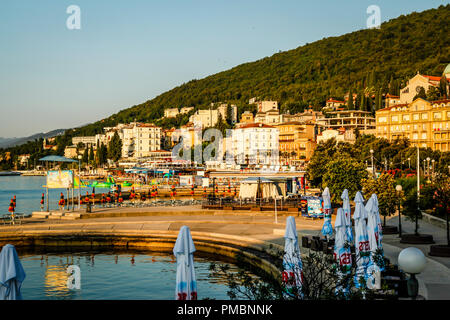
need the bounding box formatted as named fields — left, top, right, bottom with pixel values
left=353, top=191, right=370, bottom=287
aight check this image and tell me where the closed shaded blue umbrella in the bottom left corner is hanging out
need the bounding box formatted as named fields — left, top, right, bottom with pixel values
left=0, top=244, right=25, bottom=300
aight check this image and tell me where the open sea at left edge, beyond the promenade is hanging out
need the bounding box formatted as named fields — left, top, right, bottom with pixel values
left=0, top=176, right=108, bottom=214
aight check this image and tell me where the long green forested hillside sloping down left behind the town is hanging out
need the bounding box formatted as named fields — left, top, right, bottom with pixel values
left=48, top=5, right=450, bottom=135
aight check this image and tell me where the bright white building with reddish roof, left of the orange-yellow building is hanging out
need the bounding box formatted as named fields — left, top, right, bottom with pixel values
left=230, top=123, right=279, bottom=165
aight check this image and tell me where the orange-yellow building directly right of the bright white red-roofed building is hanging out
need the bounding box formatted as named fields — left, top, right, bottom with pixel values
left=275, top=121, right=316, bottom=164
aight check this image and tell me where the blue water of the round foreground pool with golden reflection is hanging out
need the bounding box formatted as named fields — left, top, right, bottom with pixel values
left=19, top=252, right=244, bottom=300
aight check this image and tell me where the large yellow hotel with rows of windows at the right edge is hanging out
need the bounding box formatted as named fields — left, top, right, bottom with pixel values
left=376, top=98, right=450, bottom=151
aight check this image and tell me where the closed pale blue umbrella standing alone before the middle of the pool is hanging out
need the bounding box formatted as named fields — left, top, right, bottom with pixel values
left=173, top=226, right=197, bottom=300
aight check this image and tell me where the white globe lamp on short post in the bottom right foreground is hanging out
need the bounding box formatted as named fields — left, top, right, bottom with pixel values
left=398, top=247, right=427, bottom=300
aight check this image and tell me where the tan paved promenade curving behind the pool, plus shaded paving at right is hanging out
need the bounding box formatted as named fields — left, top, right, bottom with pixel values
left=0, top=206, right=450, bottom=300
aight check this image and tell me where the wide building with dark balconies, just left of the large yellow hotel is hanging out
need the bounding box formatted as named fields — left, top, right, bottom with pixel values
left=317, top=110, right=376, bottom=130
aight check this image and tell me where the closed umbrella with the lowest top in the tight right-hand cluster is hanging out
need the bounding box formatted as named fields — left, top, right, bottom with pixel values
left=334, top=208, right=352, bottom=292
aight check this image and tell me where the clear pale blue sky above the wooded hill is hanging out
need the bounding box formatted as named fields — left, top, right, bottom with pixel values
left=0, top=0, right=448, bottom=137
